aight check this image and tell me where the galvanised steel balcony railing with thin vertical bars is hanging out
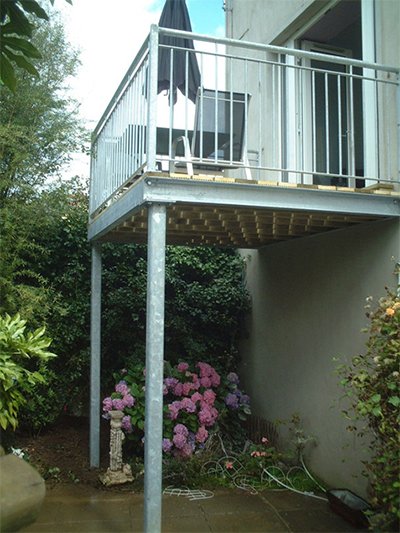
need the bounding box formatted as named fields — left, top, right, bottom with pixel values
left=90, top=26, right=400, bottom=216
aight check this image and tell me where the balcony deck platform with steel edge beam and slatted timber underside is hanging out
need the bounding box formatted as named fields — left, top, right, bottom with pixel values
left=89, top=172, right=400, bottom=248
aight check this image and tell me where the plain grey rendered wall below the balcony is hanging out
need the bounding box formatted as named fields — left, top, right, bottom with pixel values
left=242, top=220, right=400, bottom=494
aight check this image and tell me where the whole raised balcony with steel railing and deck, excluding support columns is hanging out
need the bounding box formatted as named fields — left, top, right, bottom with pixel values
left=89, top=26, right=400, bottom=248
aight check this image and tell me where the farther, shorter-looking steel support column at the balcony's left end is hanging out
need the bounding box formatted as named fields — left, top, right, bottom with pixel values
left=90, top=244, right=101, bottom=468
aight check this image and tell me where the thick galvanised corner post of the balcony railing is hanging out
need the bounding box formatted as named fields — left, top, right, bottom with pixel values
left=146, top=24, right=159, bottom=171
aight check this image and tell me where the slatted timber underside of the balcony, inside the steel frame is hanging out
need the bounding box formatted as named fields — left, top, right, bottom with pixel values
left=101, top=204, right=380, bottom=248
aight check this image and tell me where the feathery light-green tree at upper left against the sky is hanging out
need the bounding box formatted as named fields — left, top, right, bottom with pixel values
left=0, top=14, right=85, bottom=206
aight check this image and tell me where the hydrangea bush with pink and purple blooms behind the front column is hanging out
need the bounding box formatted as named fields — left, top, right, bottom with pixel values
left=103, top=362, right=250, bottom=458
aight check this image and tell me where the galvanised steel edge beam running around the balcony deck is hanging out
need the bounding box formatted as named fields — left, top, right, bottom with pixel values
left=88, top=173, right=400, bottom=240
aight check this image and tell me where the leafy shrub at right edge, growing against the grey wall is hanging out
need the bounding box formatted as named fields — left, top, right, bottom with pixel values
left=339, top=284, right=400, bottom=530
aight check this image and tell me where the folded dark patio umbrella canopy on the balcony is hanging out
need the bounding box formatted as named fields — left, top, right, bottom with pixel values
left=158, top=0, right=200, bottom=103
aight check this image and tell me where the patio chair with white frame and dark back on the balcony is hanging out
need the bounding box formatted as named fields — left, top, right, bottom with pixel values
left=170, top=87, right=251, bottom=179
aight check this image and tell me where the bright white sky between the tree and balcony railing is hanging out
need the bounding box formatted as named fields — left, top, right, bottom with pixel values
left=57, top=0, right=160, bottom=127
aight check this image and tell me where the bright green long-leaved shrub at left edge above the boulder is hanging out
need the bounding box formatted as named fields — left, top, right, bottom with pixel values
left=0, top=314, right=55, bottom=429
